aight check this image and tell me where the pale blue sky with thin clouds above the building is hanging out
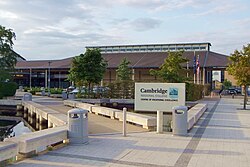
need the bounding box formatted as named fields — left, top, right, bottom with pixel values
left=0, top=0, right=250, bottom=60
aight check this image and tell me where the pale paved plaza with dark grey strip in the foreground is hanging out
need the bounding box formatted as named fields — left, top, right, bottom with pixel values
left=8, top=98, right=250, bottom=167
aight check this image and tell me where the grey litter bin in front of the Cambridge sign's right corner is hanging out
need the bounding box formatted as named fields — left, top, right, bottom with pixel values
left=172, top=106, right=188, bottom=136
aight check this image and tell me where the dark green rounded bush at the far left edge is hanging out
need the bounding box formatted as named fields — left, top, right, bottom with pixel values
left=0, top=82, right=18, bottom=99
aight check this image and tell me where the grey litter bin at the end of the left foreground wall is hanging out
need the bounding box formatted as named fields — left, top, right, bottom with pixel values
left=68, top=108, right=88, bottom=144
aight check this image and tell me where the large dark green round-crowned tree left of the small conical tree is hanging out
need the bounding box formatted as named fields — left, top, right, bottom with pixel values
left=68, top=49, right=107, bottom=95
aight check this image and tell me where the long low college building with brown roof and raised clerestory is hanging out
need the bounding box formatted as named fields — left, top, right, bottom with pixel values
left=14, top=42, right=232, bottom=88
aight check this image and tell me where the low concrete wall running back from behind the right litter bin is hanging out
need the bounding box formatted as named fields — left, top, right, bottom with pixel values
left=188, top=103, right=207, bottom=130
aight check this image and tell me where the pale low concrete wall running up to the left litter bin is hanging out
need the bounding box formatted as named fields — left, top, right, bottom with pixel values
left=4, top=126, right=68, bottom=157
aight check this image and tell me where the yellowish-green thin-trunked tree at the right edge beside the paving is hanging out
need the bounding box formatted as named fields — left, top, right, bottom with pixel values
left=227, top=44, right=250, bottom=109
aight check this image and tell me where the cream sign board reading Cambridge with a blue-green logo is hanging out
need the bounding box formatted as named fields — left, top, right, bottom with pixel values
left=135, top=83, right=186, bottom=111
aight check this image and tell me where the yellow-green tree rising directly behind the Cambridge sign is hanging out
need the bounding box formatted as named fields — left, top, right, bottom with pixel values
left=149, top=51, right=188, bottom=83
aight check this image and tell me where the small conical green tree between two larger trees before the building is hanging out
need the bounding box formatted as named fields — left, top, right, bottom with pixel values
left=116, top=57, right=132, bottom=81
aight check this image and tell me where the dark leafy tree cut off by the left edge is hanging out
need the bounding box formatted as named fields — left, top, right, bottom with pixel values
left=0, top=25, right=17, bottom=81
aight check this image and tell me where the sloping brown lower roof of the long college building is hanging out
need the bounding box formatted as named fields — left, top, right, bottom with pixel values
left=16, top=51, right=229, bottom=69
